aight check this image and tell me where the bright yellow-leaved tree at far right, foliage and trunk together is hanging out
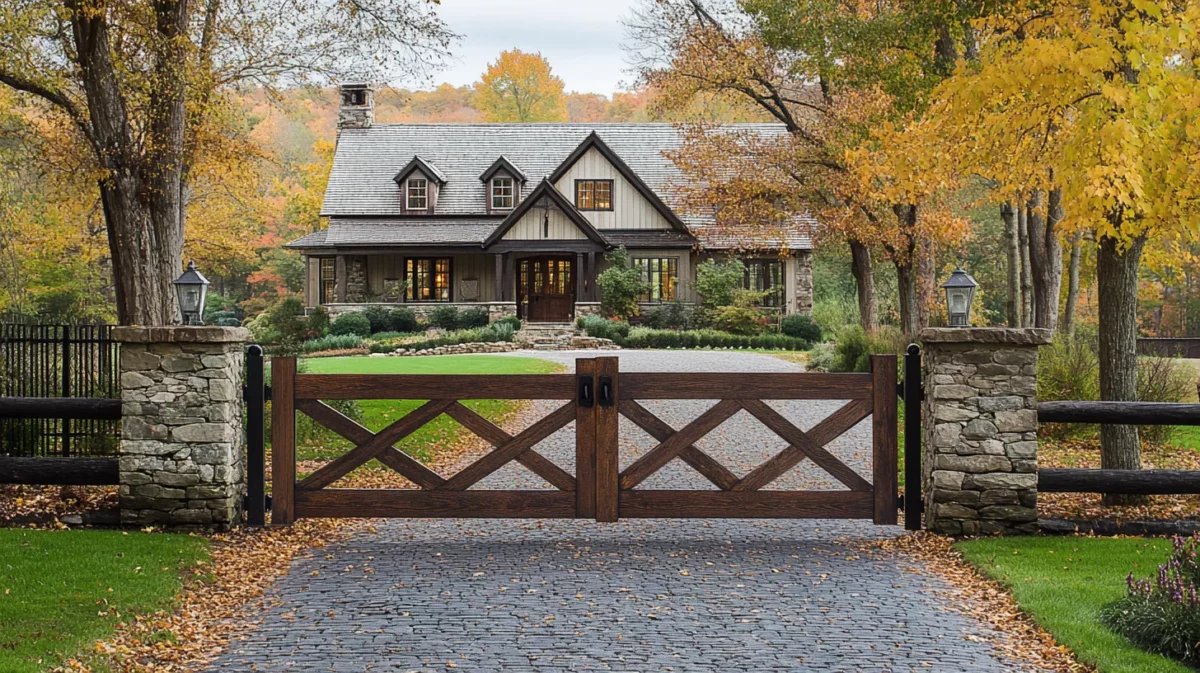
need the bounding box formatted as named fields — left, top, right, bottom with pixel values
left=932, top=0, right=1200, bottom=504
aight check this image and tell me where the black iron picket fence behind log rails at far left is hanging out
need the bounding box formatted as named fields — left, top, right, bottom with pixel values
left=0, top=323, right=120, bottom=457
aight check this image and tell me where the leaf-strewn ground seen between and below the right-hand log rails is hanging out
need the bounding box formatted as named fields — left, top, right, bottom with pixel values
left=1038, top=439, right=1200, bottom=521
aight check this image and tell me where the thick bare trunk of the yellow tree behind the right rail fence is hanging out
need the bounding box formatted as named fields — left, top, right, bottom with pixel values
left=1097, top=230, right=1146, bottom=505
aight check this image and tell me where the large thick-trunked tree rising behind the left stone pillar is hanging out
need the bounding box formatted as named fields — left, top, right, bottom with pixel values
left=0, top=0, right=454, bottom=325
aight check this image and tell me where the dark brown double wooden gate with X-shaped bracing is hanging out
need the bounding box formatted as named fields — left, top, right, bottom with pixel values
left=271, top=355, right=898, bottom=524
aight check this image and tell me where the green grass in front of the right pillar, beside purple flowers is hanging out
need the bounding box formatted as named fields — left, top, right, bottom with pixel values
left=955, top=537, right=1190, bottom=673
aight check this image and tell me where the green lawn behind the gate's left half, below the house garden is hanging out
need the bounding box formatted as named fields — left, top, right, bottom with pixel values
left=296, top=355, right=562, bottom=460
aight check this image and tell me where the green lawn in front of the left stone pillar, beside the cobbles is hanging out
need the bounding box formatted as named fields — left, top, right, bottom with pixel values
left=0, top=528, right=208, bottom=673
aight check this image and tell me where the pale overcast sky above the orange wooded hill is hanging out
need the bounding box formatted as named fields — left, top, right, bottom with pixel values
left=433, top=0, right=635, bottom=96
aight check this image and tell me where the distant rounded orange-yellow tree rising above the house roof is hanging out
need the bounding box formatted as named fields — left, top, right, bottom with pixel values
left=474, top=49, right=568, bottom=122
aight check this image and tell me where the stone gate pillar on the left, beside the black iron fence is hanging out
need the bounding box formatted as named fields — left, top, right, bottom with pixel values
left=113, top=326, right=250, bottom=528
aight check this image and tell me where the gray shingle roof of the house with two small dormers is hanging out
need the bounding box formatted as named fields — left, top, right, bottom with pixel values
left=322, top=124, right=811, bottom=250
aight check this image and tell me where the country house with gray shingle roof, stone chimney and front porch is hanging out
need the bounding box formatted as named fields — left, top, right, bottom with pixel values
left=288, top=84, right=814, bottom=323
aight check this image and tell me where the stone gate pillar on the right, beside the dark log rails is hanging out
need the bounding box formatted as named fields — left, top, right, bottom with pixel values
left=920, top=328, right=1051, bottom=535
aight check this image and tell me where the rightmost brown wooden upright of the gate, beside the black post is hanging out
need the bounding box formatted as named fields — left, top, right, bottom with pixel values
left=871, top=355, right=899, bottom=525
